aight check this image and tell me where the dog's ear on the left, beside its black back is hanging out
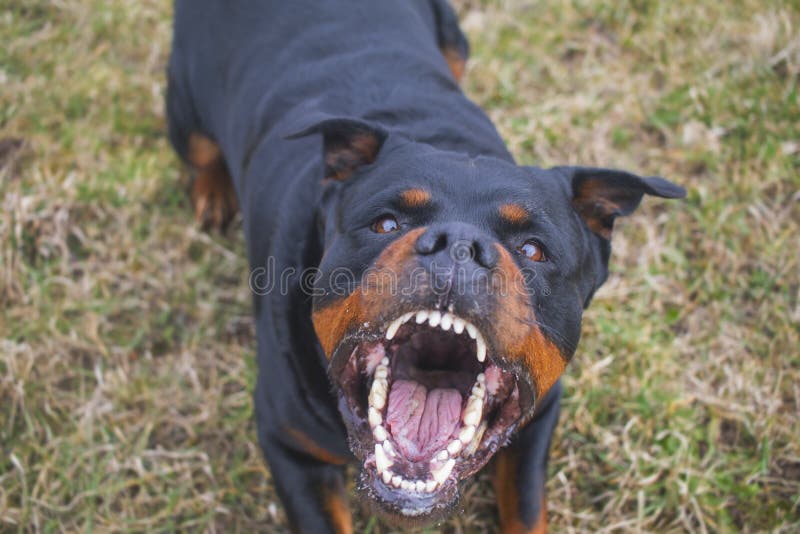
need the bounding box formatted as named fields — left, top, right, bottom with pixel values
left=284, top=118, right=388, bottom=181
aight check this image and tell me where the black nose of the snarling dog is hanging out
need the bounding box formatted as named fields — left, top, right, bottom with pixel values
left=415, top=223, right=498, bottom=269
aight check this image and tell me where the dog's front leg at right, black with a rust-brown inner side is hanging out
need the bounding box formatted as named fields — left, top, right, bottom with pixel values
left=494, top=382, right=561, bottom=534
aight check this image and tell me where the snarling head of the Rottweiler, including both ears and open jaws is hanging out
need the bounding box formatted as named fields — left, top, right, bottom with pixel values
left=290, top=119, right=684, bottom=521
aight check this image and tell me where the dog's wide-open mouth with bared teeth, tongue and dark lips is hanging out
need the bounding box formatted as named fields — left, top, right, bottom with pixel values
left=335, top=310, right=530, bottom=516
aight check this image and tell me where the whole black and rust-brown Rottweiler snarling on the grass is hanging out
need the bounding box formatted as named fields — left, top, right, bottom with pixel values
left=167, top=0, right=684, bottom=533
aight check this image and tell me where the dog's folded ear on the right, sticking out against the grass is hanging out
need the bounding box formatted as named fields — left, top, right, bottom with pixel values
left=557, top=167, right=686, bottom=240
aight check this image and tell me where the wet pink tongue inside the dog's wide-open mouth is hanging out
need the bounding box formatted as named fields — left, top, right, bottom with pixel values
left=386, top=380, right=461, bottom=461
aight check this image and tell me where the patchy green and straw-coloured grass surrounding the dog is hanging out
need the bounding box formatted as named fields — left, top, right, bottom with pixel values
left=0, top=0, right=800, bottom=532
